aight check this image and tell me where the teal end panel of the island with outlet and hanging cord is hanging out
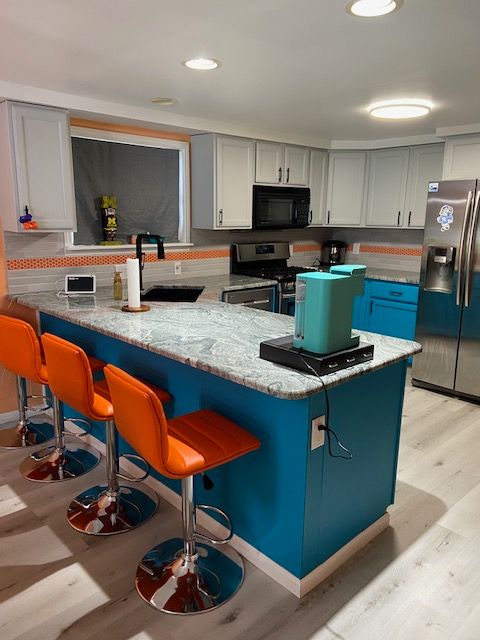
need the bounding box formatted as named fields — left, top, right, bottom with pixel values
left=302, top=360, right=406, bottom=577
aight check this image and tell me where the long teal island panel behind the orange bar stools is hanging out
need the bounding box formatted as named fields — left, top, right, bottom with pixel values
left=41, top=313, right=310, bottom=577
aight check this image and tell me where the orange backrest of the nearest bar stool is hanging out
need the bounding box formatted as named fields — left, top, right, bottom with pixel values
left=104, top=364, right=172, bottom=477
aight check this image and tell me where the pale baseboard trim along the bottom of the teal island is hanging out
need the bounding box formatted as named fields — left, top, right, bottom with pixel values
left=55, top=422, right=390, bottom=598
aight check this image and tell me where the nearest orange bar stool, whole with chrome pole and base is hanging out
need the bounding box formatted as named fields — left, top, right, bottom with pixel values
left=105, top=365, right=260, bottom=614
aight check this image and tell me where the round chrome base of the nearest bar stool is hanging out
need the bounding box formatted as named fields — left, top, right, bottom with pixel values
left=135, top=538, right=244, bottom=615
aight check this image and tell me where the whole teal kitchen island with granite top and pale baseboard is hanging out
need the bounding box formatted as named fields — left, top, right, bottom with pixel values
left=13, top=290, right=420, bottom=596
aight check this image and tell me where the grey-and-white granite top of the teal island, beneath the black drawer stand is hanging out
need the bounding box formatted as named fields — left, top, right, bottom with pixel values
left=10, top=287, right=421, bottom=400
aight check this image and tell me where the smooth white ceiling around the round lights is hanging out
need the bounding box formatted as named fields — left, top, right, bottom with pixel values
left=0, top=0, right=480, bottom=141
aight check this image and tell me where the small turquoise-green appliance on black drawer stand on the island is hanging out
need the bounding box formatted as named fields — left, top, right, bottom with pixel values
left=293, top=264, right=366, bottom=354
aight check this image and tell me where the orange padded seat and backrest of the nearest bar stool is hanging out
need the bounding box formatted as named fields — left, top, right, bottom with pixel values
left=105, top=364, right=260, bottom=478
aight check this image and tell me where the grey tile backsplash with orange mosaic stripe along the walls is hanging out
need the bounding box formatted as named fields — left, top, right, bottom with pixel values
left=5, top=227, right=423, bottom=293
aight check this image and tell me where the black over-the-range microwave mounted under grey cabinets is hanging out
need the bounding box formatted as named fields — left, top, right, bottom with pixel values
left=253, top=185, right=311, bottom=229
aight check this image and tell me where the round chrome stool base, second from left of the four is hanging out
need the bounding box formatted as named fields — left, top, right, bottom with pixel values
left=20, top=443, right=100, bottom=482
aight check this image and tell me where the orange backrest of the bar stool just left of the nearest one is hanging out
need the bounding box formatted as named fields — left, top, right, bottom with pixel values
left=42, top=333, right=95, bottom=419
